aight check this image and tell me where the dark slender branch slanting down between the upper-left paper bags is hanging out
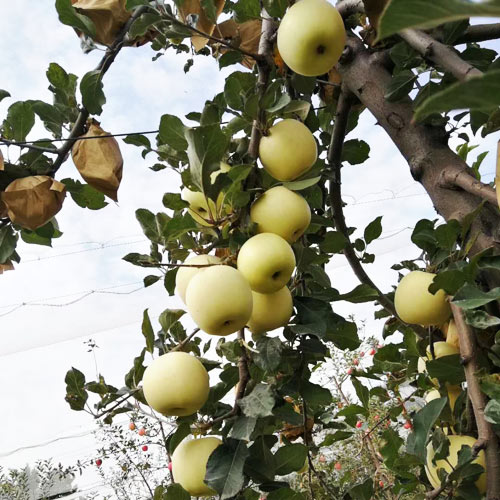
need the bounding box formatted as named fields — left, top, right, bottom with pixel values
left=50, top=5, right=148, bottom=176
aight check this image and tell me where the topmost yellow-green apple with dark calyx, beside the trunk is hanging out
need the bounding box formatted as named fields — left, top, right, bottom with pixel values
left=277, top=0, right=346, bottom=76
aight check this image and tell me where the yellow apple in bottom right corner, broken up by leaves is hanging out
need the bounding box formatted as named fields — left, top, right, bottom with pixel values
left=425, top=436, right=486, bottom=493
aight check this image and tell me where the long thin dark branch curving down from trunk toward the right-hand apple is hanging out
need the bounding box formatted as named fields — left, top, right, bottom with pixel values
left=328, top=88, right=396, bottom=315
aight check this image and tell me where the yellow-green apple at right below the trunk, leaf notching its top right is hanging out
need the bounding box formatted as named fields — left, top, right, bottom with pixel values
left=394, top=271, right=451, bottom=326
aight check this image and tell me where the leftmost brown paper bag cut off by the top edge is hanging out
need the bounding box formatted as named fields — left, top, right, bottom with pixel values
left=71, top=0, right=131, bottom=45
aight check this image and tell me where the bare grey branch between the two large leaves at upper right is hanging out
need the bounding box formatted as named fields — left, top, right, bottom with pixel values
left=399, top=29, right=483, bottom=80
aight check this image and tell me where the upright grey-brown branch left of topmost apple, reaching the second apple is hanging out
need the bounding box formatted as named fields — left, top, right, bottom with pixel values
left=248, top=9, right=275, bottom=159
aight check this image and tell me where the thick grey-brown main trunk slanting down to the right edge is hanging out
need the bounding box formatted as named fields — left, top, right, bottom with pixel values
left=337, top=36, right=500, bottom=266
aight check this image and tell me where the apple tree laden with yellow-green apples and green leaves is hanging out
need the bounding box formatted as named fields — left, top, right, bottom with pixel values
left=0, top=0, right=500, bottom=500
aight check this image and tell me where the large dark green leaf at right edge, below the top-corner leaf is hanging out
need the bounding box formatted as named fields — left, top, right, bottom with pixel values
left=415, top=70, right=500, bottom=120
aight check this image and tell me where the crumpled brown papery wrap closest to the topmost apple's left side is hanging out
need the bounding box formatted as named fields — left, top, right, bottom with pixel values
left=209, top=19, right=262, bottom=69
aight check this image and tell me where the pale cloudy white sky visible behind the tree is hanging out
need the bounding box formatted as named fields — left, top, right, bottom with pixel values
left=0, top=0, right=498, bottom=496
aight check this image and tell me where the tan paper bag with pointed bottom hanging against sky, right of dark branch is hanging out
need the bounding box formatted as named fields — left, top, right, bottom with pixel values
left=71, top=122, right=123, bottom=201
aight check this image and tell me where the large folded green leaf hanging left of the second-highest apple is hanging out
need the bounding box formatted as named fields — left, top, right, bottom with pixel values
left=185, top=125, right=230, bottom=197
